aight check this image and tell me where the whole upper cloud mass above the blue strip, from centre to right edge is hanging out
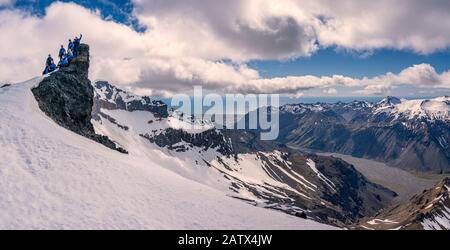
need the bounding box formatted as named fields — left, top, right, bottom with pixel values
left=134, top=0, right=450, bottom=56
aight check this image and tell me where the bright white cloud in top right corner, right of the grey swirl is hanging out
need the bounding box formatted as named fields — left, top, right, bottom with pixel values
left=315, top=0, right=450, bottom=54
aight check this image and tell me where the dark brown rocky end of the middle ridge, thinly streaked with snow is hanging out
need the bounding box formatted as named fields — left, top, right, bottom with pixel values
left=230, top=150, right=396, bottom=227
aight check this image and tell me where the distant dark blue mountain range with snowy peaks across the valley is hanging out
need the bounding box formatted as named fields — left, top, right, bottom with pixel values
left=268, top=96, right=450, bottom=173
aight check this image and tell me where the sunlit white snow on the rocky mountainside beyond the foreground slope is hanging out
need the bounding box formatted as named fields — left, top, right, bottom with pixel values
left=92, top=102, right=321, bottom=216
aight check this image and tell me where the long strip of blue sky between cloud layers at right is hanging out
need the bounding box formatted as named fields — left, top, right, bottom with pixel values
left=250, top=48, right=450, bottom=77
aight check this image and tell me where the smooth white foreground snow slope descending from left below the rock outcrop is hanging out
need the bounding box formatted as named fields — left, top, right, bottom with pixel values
left=0, top=78, right=332, bottom=229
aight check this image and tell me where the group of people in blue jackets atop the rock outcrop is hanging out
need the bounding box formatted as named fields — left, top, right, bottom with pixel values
left=42, top=34, right=83, bottom=75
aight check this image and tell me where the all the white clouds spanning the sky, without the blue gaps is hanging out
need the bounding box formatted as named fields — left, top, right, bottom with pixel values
left=0, top=0, right=450, bottom=95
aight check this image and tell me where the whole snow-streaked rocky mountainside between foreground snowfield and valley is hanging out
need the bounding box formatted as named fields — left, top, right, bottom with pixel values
left=92, top=81, right=394, bottom=226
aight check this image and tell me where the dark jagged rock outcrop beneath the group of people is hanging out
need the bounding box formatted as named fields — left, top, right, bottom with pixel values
left=32, top=44, right=126, bottom=153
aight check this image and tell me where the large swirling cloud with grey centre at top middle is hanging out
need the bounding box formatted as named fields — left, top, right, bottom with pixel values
left=135, top=0, right=317, bottom=61
